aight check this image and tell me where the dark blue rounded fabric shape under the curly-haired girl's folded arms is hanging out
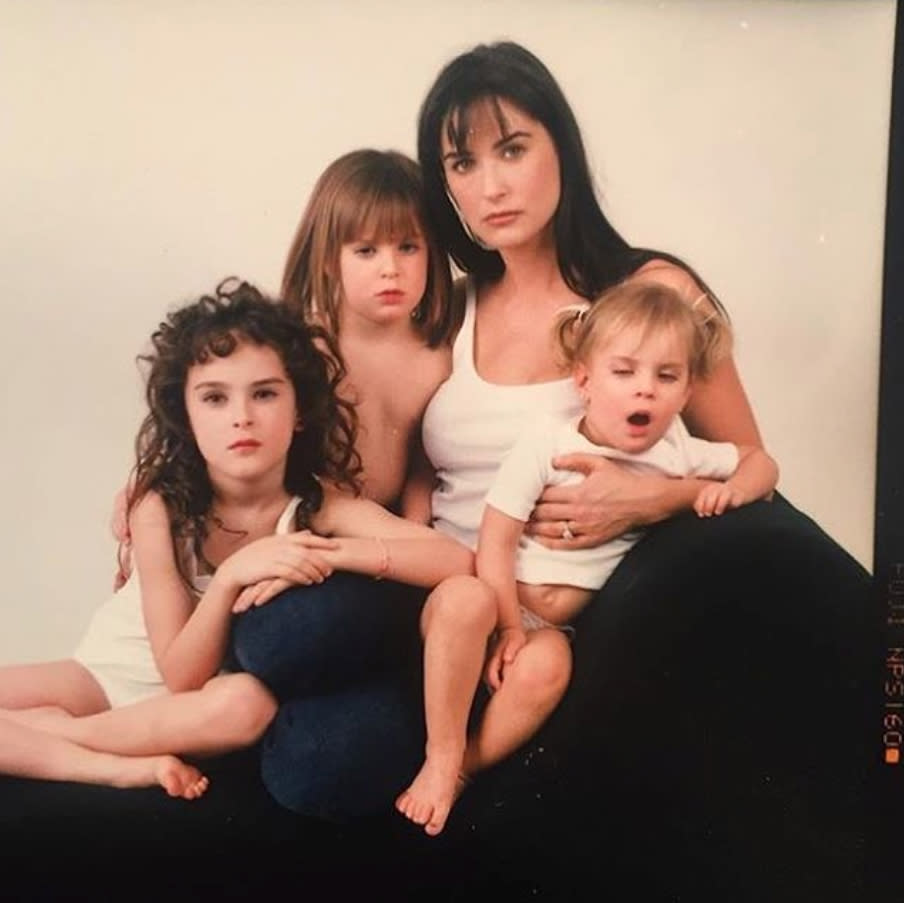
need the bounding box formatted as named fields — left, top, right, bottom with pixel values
left=226, top=572, right=425, bottom=820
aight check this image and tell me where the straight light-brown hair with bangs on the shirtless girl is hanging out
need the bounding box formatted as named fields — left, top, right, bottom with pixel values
left=281, top=149, right=457, bottom=348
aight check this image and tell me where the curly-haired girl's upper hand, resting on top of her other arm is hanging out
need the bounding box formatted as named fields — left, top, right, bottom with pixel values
left=214, top=530, right=338, bottom=604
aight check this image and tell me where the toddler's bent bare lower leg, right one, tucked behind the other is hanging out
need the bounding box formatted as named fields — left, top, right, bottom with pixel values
left=463, top=628, right=571, bottom=775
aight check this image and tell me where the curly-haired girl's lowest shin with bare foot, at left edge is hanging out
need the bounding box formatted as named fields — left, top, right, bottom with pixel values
left=0, top=720, right=208, bottom=799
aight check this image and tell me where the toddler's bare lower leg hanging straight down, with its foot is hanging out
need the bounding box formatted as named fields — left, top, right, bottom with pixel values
left=396, top=577, right=496, bottom=835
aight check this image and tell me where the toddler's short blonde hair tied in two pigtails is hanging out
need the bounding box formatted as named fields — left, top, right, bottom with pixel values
left=555, top=278, right=732, bottom=380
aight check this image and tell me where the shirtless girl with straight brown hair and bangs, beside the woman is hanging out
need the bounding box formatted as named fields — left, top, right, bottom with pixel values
left=282, top=149, right=461, bottom=521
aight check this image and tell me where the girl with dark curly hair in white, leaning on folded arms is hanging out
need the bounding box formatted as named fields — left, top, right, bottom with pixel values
left=0, top=281, right=472, bottom=799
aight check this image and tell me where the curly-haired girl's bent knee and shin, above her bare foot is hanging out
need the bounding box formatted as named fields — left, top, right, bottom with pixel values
left=5, top=673, right=276, bottom=756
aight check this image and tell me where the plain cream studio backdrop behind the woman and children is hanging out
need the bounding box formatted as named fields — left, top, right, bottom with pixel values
left=0, top=0, right=895, bottom=663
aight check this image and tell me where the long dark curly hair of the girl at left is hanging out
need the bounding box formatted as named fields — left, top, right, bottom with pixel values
left=127, top=277, right=361, bottom=577
